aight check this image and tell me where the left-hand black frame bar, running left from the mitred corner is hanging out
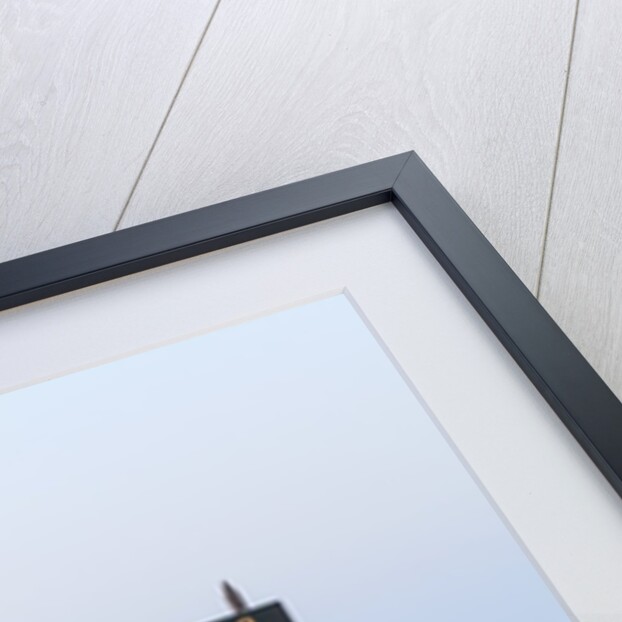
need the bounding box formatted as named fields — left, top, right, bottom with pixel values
left=0, top=152, right=411, bottom=311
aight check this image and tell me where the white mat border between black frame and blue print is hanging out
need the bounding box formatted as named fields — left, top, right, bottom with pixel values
left=0, top=206, right=622, bottom=622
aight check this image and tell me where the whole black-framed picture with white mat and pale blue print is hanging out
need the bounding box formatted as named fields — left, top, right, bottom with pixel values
left=0, top=152, right=622, bottom=622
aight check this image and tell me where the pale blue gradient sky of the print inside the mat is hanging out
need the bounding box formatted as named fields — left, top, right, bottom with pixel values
left=0, top=296, right=569, bottom=622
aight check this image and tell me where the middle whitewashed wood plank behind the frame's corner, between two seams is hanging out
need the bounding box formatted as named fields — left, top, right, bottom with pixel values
left=122, top=0, right=574, bottom=287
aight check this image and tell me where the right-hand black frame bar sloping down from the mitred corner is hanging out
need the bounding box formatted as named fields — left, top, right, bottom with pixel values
left=393, top=153, right=622, bottom=497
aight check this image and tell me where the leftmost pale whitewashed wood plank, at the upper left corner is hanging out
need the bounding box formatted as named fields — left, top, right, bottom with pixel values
left=0, top=0, right=219, bottom=261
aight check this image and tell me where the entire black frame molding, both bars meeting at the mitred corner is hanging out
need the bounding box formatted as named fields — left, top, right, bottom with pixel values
left=0, top=151, right=622, bottom=496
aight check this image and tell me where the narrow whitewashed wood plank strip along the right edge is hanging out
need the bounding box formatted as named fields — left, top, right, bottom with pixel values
left=540, top=0, right=622, bottom=398
